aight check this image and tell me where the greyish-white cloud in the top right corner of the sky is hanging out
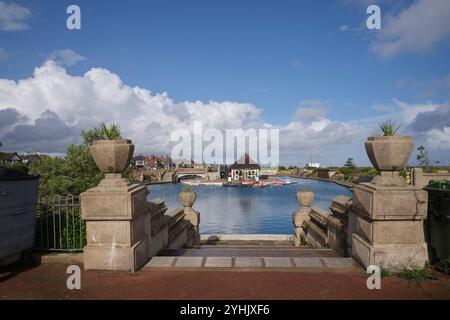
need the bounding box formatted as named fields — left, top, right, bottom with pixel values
left=371, top=0, right=450, bottom=58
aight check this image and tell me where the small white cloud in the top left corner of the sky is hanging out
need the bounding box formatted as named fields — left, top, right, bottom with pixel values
left=0, top=1, right=31, bottom=31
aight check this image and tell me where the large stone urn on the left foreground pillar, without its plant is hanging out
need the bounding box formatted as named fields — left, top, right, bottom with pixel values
left=90, top=139, right=134, bottom=173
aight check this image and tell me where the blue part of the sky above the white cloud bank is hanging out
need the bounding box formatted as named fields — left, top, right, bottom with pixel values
left=0, top=0, right=450, bottom=164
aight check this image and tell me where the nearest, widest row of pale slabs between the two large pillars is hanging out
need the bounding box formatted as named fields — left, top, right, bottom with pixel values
left=144, top=256, right=358, bottom=271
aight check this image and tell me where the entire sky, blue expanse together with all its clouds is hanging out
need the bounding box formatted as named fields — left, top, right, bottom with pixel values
left=0, top=0, right=450, bottom=166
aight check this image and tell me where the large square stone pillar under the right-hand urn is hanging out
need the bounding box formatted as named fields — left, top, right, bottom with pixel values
left=349, top=178, right=428, bottom=271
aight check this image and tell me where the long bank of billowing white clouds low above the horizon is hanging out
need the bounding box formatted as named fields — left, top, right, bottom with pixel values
left=0, top=61, right=450, bottom=164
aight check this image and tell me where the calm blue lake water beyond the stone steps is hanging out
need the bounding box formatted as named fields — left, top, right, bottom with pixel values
left=148, top=179, right=351, bottom=234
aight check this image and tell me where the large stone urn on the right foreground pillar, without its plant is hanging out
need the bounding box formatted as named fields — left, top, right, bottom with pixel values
left=365, top=136, right=414, bottom=172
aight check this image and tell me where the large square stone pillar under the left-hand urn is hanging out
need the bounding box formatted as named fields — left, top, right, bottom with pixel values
left=81, top=173, right=151, bottom=272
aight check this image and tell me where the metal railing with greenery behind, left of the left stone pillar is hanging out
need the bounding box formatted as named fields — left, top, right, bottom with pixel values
left=35, top=195, right=86, bottom=252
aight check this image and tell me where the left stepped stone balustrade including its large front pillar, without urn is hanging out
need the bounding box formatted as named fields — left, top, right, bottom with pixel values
left=81, top=161, right=200, bottom=272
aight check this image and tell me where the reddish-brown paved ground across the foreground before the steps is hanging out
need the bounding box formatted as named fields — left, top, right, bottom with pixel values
left=0, top=265, right=450, bottom=300
